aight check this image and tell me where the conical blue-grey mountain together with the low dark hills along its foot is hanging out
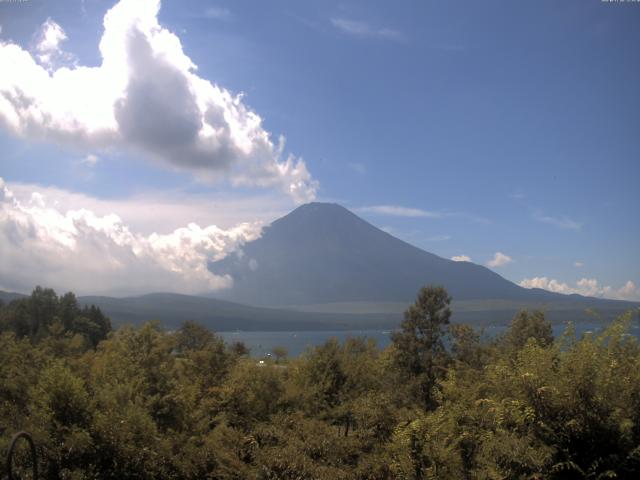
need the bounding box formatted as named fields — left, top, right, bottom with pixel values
left=0, top=203, right=640, bottom=331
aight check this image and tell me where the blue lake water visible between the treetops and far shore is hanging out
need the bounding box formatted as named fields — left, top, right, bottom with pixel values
left=217, top=322, right=640, bottom=357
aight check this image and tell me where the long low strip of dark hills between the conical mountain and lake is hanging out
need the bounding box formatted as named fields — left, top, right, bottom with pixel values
left=0, top=284, right=639, bottom=331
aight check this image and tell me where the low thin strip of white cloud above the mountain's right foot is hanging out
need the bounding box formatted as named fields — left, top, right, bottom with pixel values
left=518, top=277, right=640, bottom=300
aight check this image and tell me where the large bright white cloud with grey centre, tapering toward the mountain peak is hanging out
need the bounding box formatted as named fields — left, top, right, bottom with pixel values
left=0, top=0, right=318, bottom=202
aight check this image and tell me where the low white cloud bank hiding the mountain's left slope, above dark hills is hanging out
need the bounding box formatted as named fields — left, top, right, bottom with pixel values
left=0, top=179, right=261, bottom=294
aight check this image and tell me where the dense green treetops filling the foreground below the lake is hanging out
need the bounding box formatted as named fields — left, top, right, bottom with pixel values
left=0, top=287, right=640, bottom=480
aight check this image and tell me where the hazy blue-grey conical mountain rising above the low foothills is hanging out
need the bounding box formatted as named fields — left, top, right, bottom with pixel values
left=210, top=203, right=557, bottom=305
